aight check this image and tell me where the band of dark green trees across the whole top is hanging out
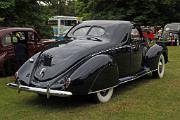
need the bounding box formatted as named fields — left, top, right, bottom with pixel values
left=0, top=0, right=180, bottom=36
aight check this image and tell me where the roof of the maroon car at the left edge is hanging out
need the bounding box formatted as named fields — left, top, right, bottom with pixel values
left=0, top=27, right=35, bottom=37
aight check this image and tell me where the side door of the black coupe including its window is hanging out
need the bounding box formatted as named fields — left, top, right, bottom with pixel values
left=130, top=27, right=143, bottom=75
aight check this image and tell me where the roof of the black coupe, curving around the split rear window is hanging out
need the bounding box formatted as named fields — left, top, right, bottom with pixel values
left=68, top=20, right=134, bottom=42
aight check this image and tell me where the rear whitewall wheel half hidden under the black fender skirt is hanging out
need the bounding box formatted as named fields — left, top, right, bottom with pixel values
left=94, top=88, right=113, bottom=103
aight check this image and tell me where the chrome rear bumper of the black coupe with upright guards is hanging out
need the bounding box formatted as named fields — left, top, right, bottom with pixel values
left=7, top=83, right=72, bottom=98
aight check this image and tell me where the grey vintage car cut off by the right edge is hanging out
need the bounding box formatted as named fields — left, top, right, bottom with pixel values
left=162, top=23, right=180, bottom=45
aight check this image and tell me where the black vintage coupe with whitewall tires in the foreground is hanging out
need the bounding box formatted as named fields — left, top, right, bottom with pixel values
left=8, top=20, right=168, bottom=102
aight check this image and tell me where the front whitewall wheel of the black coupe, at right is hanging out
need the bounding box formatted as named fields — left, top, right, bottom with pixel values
left=152, top=54, right=165, bottom=78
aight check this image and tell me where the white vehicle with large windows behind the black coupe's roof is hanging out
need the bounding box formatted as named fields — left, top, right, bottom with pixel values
left=48, top=16, right=82, bottom=40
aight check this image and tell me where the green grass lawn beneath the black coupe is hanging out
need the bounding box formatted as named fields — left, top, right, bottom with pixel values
left=0, top=46, right=180, bottom=120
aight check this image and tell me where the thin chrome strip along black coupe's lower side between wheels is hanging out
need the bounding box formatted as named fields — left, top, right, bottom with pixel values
left=88, top=69, right=157, bottom=94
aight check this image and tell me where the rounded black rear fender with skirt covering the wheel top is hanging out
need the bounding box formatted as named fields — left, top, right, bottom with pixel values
left=68, top=54, right=118, bottom=95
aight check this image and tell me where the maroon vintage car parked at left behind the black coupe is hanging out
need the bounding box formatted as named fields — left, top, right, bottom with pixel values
left=0, top=27, right=54, bottom=75
